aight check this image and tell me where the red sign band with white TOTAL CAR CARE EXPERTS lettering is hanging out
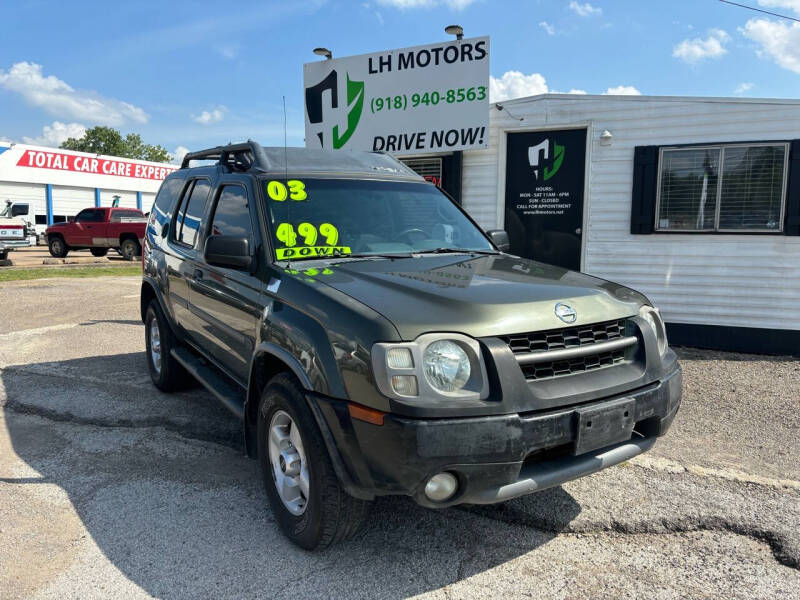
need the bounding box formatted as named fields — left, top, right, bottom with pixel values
left=17, top=150, right=177, bottom=180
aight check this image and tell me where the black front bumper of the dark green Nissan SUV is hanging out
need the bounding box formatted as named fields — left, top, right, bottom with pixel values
left=314, top=366, right=682, bottom=508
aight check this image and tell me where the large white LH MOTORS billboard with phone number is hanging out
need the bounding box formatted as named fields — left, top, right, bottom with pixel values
left=303, top=37, right=489, bottom=154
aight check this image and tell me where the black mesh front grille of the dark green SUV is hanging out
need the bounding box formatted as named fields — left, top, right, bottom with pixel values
left=500, top=319, right=627, bottom=380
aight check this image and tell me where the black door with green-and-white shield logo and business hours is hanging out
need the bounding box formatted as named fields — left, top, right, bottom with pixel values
left=505, top=129, right=586, bottom=271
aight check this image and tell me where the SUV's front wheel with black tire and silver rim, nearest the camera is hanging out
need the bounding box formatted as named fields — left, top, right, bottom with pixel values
left=258, top=373, right=369, bottom=550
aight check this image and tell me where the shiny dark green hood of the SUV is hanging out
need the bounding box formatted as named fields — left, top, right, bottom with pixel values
left=306, top=254, right=647, bottom=340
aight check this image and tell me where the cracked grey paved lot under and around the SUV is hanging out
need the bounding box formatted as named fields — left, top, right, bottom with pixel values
left=0, top=277, right=800, bottom=599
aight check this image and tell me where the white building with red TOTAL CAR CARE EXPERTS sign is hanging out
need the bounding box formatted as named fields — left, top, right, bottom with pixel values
left=0, top=142, right=177, bottom=233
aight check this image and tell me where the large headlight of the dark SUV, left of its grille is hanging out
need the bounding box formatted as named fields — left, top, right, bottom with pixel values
left=372, top=333, right=489, bottom=401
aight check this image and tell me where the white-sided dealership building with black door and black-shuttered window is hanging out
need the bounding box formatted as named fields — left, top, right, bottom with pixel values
left=406, top=94, right=800, bottom=354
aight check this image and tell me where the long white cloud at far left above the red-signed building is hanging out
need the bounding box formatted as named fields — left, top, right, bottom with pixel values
left=0, top=61, right=150, bottom=126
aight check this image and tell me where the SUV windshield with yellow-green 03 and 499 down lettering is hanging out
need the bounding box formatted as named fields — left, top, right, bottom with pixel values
left=263, top=179, right=494, bottom=260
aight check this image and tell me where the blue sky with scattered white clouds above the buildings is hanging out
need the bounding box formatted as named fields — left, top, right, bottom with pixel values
left=0, top=0, right=800, bottom=162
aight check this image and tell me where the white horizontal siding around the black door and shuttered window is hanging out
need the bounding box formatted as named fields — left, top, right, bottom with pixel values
left=463, top=96, right=800, bottom=330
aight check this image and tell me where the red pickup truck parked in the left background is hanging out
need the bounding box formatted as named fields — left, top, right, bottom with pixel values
left=45, top=208, right=147, bottom=260
